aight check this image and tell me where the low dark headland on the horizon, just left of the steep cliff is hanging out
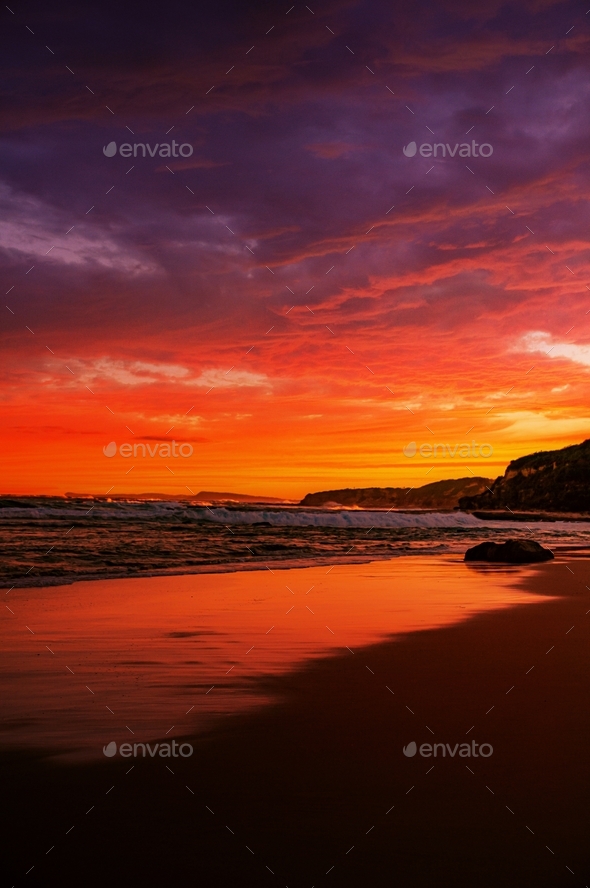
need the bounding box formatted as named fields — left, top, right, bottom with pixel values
left=300, top=477, right=492, bottom=509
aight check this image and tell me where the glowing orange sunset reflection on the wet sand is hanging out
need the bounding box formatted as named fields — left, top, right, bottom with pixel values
left=1, top=556, right=547, bottom=757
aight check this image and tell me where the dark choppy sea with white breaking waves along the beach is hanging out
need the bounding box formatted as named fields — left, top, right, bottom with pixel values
left=0, top=496, right=590, bottom=588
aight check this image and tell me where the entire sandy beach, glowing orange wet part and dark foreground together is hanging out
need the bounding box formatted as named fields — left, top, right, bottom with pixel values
left=2, top=556, right=590, bottom=888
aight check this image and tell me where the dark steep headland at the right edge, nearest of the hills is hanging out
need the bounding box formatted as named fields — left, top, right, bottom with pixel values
left=459, top=440, right=590, bottom=512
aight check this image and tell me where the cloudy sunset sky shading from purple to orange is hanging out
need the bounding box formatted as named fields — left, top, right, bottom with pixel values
left=0, top=0, right=590, bottom=500
